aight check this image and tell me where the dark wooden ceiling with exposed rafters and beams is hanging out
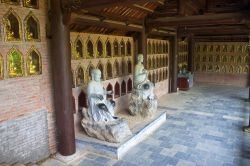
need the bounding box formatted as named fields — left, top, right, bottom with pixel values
left=68, top=0, right=250, bottom=36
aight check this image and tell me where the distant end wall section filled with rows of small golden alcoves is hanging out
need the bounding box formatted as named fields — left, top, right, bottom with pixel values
left=194, top=42, right=250, bottom=74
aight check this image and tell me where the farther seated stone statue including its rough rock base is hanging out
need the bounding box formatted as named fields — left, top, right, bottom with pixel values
left=129, top=54, right=157, bottom=117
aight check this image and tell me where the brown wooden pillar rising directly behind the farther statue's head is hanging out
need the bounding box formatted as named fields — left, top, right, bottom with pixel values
left=136, top=21, right=148, bottom=69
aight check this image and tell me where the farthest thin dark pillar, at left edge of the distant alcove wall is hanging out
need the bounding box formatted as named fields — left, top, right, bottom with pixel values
left=188, top=34, right=195, bottom=73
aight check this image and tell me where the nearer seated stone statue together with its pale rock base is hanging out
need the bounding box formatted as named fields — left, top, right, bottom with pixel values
left=81, top=69, right=132, bottom=143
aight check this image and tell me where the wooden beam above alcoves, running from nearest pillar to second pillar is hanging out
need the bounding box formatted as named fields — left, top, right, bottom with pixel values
left=70, top=13, right=143, bottom=32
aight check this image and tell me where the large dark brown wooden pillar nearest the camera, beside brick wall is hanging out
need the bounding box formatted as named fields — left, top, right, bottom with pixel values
left=51, top=0, right=75, bottom=156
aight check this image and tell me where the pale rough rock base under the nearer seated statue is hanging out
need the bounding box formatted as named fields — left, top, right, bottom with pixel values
left=81, top=112, right=132, bottom=143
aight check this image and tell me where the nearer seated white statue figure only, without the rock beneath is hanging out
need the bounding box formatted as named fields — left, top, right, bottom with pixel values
left=87, top=69, right=116, bottom=122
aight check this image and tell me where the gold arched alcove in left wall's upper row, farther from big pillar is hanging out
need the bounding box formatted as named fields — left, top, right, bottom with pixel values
left=3, top=9, right=21, bottom=41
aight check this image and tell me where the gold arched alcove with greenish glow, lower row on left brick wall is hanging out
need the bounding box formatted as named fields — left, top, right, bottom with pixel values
left=8, top=48, right=24, bottom=78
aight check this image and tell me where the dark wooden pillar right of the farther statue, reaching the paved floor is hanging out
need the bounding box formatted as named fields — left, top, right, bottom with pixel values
left=169, top=35, right=177, bottom=93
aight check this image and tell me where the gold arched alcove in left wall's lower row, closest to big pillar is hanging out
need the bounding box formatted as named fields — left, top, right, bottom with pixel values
left=27, top=48, right=42, bottom=75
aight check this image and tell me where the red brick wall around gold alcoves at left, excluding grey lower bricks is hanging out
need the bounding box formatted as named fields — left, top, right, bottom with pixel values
left=0, top=0, right=56, bottom=153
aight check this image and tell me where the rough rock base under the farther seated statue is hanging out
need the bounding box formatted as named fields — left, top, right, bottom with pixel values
left=129, top=90, right=157, bottom=117
